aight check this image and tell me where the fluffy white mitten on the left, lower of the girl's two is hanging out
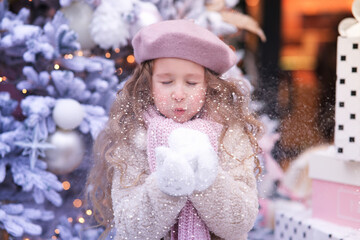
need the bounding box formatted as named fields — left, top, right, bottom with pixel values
left=155, top=147, right=195, bottom=196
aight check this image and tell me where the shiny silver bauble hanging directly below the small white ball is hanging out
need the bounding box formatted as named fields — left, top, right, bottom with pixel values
left=46, top=130, right=84, bottom=175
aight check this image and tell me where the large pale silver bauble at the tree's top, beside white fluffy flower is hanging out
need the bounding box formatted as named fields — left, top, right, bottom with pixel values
left=60, top=1, right=96, bottom=49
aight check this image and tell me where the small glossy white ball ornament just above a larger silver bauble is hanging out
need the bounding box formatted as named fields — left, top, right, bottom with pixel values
left=53, top=99, right=85, bottom=130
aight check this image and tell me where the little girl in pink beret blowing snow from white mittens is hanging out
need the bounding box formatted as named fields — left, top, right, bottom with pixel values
left=87, top=20, right=261, bottom=240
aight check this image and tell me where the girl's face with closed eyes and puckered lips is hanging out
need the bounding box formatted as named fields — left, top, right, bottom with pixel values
left=151, top=58, right=206, bottom=123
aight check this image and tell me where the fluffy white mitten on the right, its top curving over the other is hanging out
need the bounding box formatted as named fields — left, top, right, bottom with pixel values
left=169, top=128, right=218, bottom=191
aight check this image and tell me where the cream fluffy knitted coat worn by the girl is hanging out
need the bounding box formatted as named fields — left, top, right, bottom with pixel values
left=111, top=124, right=258, bottom=240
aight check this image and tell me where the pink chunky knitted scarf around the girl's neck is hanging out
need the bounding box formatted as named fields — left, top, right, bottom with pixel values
left=145, top=108, right=222, bottom=240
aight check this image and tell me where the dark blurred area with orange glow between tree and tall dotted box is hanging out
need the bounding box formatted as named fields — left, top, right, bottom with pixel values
left=244, top=0, right=353, bottom=167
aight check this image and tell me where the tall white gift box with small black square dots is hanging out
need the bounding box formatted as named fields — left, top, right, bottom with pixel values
left=335, top=36, right=360, bottom=162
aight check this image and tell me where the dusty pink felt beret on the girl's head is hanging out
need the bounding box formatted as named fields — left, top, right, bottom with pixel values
left=132, top=20, right=236, bottom=74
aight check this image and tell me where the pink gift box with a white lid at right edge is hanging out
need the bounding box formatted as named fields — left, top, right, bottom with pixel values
left=309, top=146, right=360, bottom=228
